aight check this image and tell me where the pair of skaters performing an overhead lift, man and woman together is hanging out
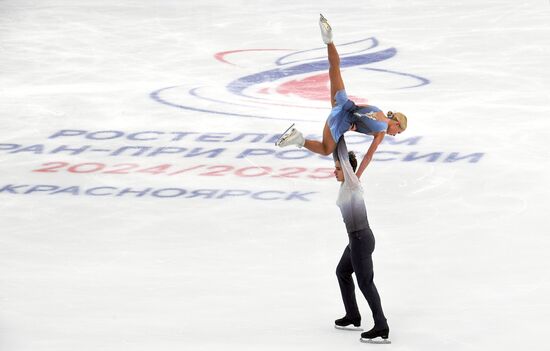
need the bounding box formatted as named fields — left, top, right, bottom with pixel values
left=276, top=15, right=407, bottom=343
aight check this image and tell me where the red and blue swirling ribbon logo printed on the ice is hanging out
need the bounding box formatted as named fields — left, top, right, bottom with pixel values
left=150, top=38, right=430, bottom=122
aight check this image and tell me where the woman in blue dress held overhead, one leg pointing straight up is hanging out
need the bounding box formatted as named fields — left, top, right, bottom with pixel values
left=275, top=15, right=407, bottom=177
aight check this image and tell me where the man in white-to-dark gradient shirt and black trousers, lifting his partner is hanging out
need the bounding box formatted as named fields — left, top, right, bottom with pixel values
left=333, top=136, right=390, bottom=344
